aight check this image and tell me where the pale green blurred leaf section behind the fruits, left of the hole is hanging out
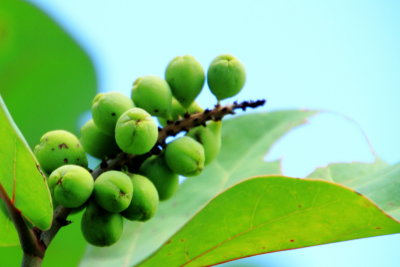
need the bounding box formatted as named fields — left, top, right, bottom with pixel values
left=81, top=110, right=316, bottom=267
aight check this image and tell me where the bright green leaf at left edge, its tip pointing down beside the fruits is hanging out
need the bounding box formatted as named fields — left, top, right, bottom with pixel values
left=0, top=96, right=53, bottom=245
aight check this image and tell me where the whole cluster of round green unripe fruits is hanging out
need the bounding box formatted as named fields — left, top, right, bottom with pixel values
left=34, top=55, right=245, bottom=246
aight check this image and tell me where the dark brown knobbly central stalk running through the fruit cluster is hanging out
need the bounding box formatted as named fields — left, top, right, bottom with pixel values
left=36, top=100, right=265, bottom=252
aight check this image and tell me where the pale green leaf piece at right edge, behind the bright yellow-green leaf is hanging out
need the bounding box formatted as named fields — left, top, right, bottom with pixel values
left=308, top=159, right=400, bottom=220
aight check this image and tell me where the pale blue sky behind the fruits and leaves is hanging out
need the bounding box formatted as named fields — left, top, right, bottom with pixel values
left=31, top=0, right=400, bottom=267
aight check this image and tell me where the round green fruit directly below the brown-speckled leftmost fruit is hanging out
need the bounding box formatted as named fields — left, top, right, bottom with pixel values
left=47, top=165, right=94, bottom=208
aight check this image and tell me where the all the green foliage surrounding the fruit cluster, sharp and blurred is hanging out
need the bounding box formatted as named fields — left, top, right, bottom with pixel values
left=0, top=0, right=400, bottom=266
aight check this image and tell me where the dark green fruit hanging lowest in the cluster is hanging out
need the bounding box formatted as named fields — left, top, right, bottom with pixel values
left=81, top=201, right=124, bottom=247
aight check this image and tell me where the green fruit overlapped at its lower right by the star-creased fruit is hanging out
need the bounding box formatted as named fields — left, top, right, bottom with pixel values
left=92, top=92, right=133, bottom=136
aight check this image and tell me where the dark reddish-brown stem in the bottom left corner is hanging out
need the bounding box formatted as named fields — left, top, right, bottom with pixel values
left=0, top=184, right=46, bottom=267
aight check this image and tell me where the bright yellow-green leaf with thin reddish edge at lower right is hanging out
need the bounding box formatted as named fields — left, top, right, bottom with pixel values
left=138, top=176, right=400, bottom=267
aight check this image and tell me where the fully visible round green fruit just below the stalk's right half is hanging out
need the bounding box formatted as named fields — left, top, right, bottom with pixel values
left=165, top=136, right=205, bottom=176
